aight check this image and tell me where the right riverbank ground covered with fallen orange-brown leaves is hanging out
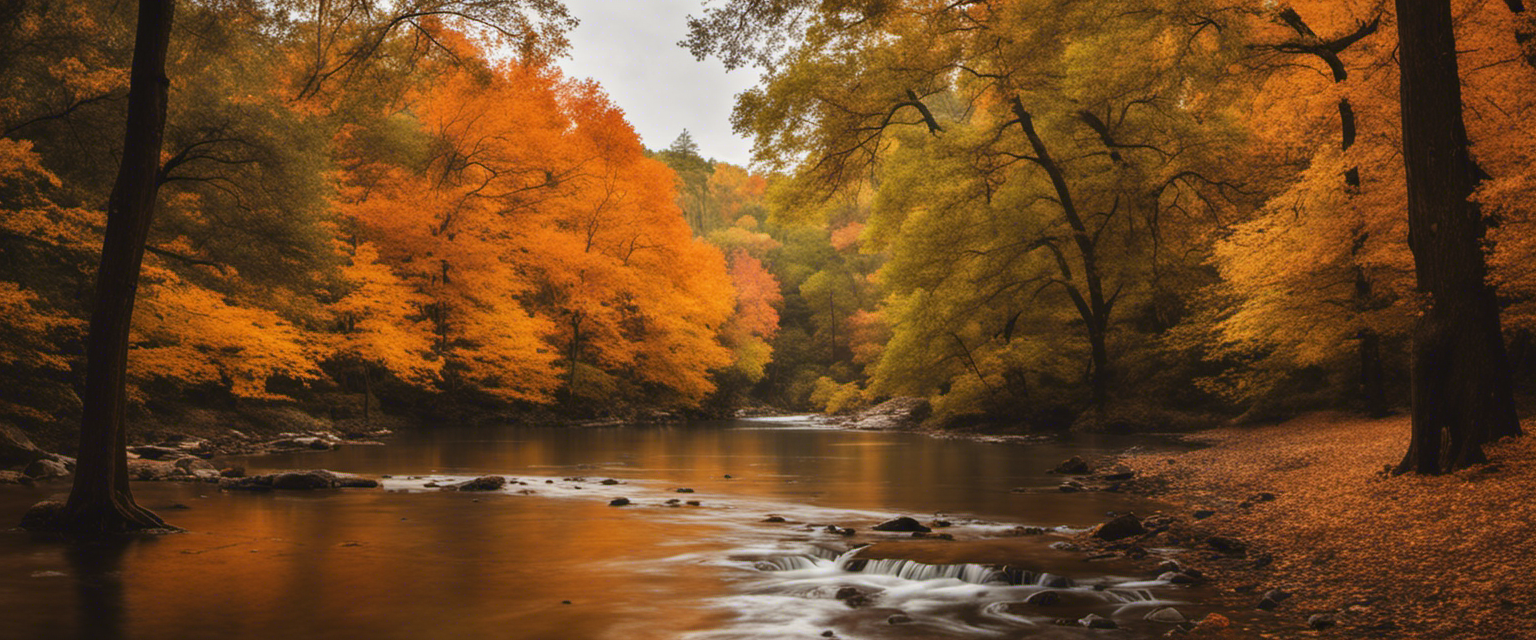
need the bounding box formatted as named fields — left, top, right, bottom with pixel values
left=1120, top=414, right=1536, bottom=640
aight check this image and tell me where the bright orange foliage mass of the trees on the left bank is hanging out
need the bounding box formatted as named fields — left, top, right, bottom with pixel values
left=336, top=54, right=734, bottom=404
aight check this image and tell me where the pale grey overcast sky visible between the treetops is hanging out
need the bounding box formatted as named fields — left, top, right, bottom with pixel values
left=561, top=0, right=757, bottom=166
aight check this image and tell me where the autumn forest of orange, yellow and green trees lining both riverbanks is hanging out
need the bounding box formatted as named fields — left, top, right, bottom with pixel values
left=0, top=0, right=1536, bottom=637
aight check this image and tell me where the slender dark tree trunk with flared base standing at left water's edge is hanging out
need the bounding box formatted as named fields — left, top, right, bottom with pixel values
left=46, top=0, right=175, bottom=534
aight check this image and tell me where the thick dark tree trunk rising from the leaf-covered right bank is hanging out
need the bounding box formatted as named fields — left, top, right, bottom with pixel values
left=1396, top=0, right=1519, bottom=473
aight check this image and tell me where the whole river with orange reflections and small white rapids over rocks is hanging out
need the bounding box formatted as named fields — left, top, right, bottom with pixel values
left=0, top=417, right=1198, bottom=640
